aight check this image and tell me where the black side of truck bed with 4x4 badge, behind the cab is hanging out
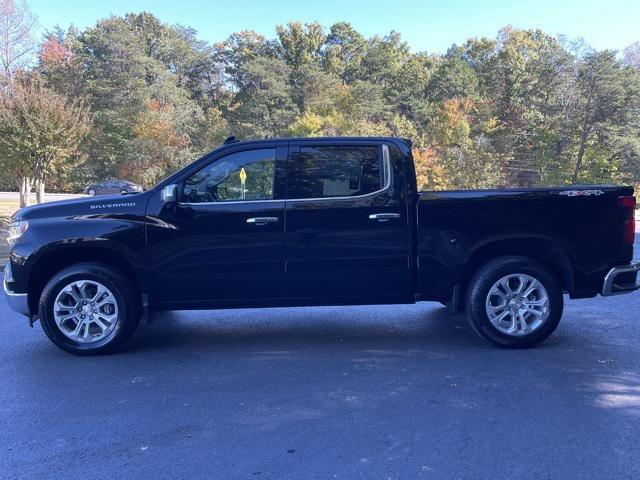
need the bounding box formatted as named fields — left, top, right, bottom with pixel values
left=417, top=185, right=633, bottom=301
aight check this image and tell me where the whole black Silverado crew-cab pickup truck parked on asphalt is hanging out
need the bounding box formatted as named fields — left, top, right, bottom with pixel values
left=4, top=138, right=640, bottom=354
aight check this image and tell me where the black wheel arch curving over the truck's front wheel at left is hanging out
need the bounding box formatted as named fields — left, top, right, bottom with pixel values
left=28, top=244, right=142, bottom=313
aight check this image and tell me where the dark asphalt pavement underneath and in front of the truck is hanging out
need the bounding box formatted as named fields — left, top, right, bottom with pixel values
left=0, top=234, right=640, bottom=479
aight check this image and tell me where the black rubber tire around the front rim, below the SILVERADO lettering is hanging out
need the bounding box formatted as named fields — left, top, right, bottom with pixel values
left=38, top=262, right=141, bottom=355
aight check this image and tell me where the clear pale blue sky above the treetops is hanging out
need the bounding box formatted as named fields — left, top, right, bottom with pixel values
left=27, top=0, right=640, bottom=53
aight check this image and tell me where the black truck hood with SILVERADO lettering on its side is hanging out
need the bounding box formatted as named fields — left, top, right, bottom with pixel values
left=13, top=190, right=152, bottom=220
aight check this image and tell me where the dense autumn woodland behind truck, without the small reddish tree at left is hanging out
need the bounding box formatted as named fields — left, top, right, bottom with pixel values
left=0, top=14, right=640, bottom=195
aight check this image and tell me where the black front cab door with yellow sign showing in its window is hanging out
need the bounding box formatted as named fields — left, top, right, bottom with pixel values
left=147, top=146, right=286, bottom=308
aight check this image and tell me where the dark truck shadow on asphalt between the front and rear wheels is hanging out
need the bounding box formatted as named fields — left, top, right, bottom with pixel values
left=126, top=304, right=492, bottom=353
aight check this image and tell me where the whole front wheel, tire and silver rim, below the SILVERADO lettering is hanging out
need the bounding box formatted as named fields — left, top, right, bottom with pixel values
left=39, top=263, right=140, bottom=355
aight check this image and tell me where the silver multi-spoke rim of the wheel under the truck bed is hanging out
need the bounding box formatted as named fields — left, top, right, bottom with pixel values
left=486, top=273, right=550, bottom=337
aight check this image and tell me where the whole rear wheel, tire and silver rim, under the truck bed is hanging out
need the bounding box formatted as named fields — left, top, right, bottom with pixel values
left=467, top=256, right=564, bottom=348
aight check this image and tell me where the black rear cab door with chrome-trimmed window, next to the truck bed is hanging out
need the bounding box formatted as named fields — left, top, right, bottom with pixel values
left=285, top=140, right=411, bottom=304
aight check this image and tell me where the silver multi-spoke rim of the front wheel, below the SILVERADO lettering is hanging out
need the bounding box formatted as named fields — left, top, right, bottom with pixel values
left=53, top=280, right=118, bottom=343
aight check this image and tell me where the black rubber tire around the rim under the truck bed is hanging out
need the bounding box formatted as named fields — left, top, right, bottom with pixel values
left=466, top=256, right=564, bottom=348
